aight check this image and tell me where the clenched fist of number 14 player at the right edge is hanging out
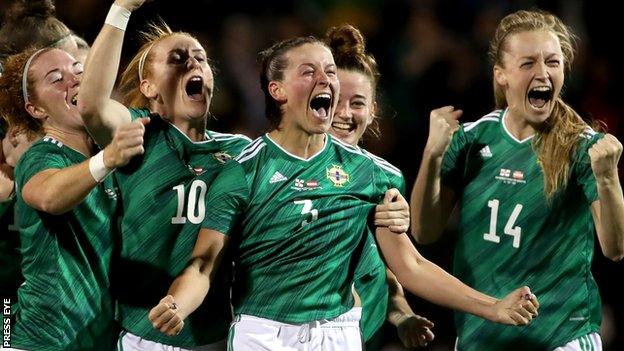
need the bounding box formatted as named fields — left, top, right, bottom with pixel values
left=588, top=134, right=622, bottom=180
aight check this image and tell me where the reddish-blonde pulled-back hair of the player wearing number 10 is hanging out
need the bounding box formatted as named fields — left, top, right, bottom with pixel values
left=119, top=20, right=201, bottom=108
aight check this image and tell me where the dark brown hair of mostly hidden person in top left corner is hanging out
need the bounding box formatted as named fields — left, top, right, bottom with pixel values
left=0, top=0, right=72, bottom=57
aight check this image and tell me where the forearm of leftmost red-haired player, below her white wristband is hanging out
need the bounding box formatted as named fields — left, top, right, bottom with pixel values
left=22, top=160, right=97, bottom=215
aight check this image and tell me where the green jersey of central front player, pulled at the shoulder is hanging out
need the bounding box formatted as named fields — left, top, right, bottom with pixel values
left=203, top=135, right=389, bottom=323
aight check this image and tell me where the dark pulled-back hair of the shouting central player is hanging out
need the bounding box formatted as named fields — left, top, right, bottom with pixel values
left=259, top=36, right=327, bottom=129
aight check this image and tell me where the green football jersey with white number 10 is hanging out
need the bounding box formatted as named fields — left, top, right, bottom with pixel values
left=114, top=110, right=250, bottom=348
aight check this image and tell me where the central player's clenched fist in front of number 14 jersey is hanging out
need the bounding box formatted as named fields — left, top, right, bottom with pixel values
left=492, top=286, right=539, bottom=325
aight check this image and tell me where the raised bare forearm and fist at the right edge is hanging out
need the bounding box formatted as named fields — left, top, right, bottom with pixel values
left=589, top=134, right=624, bottom=261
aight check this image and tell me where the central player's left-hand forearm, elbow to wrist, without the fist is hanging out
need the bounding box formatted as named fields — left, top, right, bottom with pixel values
left=169, top=258, right=210, bottom=319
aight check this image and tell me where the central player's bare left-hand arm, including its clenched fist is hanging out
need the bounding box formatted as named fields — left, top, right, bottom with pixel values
left=149, top=228, right=228, bottom=335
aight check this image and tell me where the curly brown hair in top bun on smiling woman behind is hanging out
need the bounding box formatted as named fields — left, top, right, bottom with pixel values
left=325, top=24, right=380, bottom=137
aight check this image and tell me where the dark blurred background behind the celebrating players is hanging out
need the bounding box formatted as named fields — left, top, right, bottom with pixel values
left=0, top=0, right=624, bottom=350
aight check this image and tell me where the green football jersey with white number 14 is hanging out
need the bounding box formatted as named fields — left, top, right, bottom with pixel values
left=442, top=110, right=601, bottom=351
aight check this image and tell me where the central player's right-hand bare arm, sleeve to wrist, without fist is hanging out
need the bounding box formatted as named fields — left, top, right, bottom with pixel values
left=377, top=228, right=497, bottom=321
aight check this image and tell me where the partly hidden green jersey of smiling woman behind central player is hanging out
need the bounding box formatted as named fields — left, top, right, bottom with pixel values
left=355, top=149, right=405, bottom=342
